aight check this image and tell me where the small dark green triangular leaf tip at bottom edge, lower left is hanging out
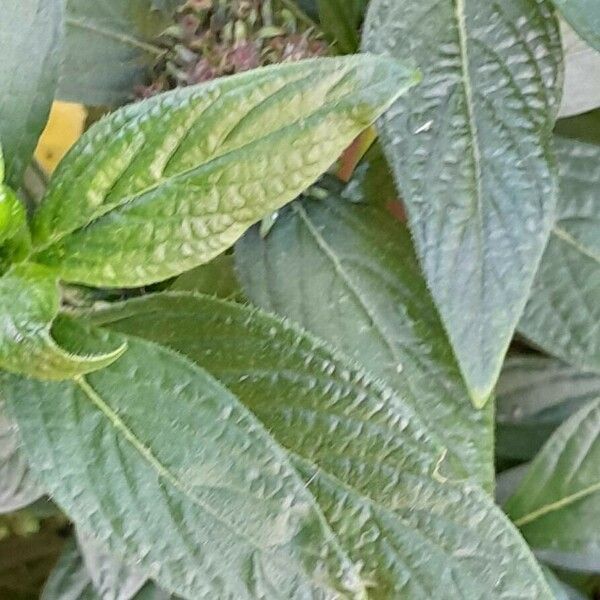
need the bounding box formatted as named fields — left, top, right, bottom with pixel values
left=40, top=539, right=102, bottom=600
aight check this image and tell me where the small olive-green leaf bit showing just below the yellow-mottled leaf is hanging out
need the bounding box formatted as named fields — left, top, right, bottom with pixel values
left=169, top=254, right=243, bottom=298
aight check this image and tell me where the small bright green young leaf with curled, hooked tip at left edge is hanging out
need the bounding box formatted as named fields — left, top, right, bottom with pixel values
left=0, top=263, right=125, bottom=380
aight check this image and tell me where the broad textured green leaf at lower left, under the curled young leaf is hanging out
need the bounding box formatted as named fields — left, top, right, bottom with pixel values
left=2, top=320, right=362, bottom=600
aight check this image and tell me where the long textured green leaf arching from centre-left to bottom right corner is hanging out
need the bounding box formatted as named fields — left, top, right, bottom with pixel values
left=96, top=294, right=551, bottom=600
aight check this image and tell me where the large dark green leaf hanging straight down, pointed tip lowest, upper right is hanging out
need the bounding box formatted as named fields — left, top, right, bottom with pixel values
left=363, top=0, right=562, bottom=407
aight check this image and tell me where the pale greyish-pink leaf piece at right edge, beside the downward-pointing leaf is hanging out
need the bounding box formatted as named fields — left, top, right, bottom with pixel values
left=559, top=21, right=600, bottom=117
